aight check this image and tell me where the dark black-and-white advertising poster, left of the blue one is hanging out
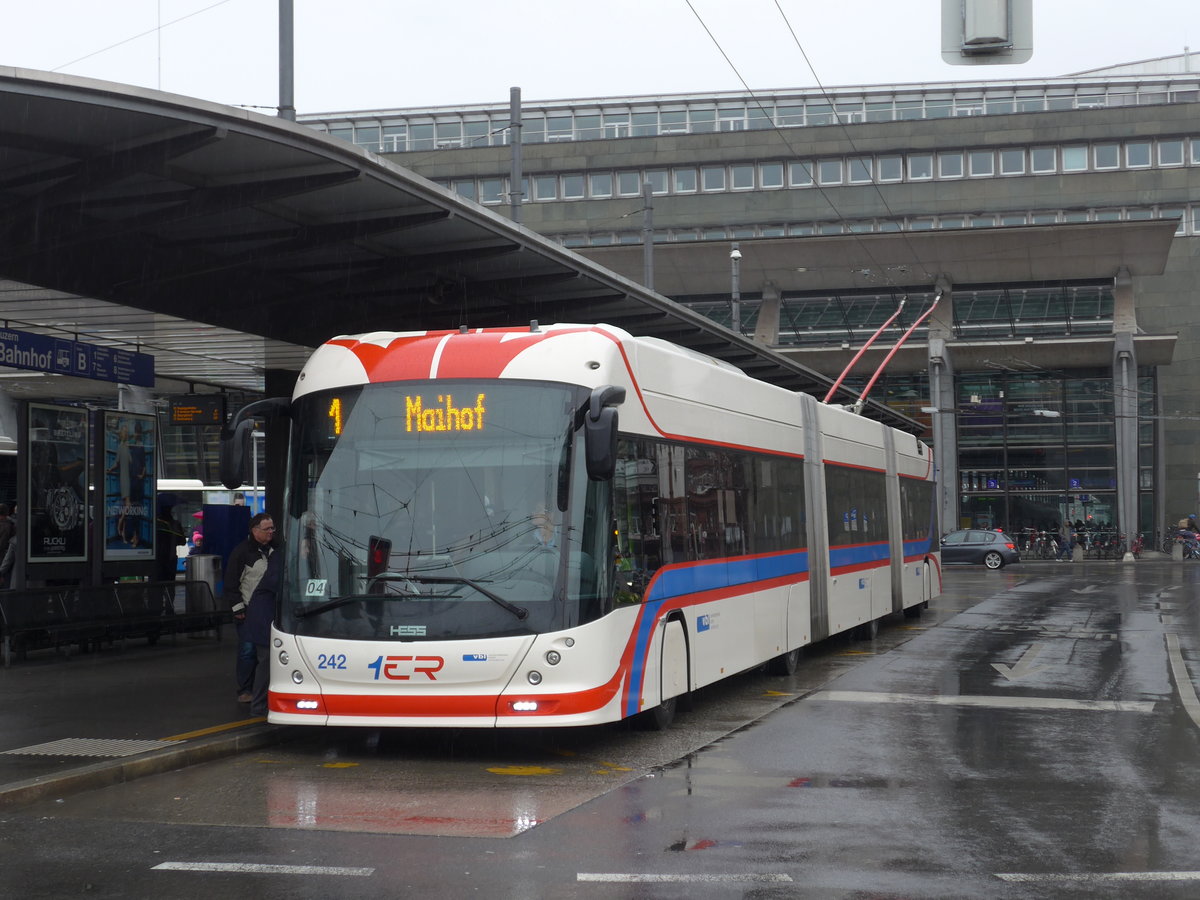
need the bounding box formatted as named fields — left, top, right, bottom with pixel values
left=25, top=403, right=88, bottom=563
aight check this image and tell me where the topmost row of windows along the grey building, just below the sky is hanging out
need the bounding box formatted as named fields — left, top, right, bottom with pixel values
left=301, top=79, right=1200, bottom=154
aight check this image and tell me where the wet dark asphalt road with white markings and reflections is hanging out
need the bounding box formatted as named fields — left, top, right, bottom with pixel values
left=0, top=562, right=1200, bottom=898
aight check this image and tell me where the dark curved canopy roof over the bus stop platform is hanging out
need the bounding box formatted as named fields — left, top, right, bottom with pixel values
left=0, top=67, right=913, bottom=427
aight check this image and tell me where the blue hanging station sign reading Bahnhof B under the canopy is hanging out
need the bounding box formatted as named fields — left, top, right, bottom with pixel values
left=0, top=328, right=154, bottom=388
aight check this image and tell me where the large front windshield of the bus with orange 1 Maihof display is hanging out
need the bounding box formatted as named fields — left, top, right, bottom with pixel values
left=280, top=380, right=612, bottom=641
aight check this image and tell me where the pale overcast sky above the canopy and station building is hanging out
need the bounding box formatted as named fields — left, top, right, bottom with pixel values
left=0, top=0, right=1200, bottom=113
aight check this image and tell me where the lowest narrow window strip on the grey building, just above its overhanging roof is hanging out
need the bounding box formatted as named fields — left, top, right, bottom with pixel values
left=547, top=204, right=1200, bottom=248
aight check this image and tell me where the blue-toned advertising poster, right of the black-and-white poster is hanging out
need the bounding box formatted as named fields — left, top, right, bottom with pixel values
left=101, top=410, right=156, bottom=562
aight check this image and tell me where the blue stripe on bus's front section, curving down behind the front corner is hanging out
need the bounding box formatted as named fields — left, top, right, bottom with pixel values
left=625, top=550, right=809, bottom=715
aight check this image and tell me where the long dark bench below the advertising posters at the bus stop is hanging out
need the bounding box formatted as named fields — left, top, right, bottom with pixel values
left=0, top=581, right=230, bottom=666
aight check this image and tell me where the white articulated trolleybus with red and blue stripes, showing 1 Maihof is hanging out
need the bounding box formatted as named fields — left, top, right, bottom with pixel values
left=222, top=325, right=941, bottom=727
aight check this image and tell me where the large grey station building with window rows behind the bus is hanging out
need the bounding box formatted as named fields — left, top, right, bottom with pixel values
left=299, top=55, right=1200, bottom=547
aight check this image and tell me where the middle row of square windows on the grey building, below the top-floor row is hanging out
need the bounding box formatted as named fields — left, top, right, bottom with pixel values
left=440, top=138, right=1200, bottom=205
